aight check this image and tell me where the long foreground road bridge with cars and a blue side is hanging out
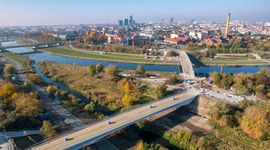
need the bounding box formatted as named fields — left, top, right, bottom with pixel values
left=31, top=89, right=199, bottom=150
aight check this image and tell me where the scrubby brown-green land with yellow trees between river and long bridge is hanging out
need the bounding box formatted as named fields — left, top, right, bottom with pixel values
left=39, top=62, right=162, bottom=112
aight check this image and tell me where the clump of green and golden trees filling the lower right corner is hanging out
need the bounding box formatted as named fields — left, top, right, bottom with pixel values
left=209, top=101, right=270, bottom=149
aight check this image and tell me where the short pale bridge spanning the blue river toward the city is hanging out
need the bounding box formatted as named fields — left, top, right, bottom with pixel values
left=179, top=50, right=195, bottom=80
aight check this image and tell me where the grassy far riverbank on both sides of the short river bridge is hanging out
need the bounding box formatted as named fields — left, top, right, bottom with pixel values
left=41, top=48, right=270, bottom=66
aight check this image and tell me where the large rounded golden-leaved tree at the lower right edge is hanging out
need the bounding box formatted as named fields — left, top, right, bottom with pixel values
left=240, top=103, right=270, bottom=139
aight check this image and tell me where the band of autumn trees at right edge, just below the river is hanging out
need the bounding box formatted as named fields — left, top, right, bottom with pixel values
left=211, top=69, right=270, bottom=100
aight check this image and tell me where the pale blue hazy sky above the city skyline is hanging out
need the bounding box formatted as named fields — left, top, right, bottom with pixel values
left=0, top=0, right=270, bottom=26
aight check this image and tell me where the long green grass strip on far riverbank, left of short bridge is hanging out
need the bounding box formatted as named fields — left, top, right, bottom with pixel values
left=42, top=48, right=162, bottom=63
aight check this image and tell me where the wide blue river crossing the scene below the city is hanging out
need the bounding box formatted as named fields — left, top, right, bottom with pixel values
left=2, top=42, right=270, bottom=74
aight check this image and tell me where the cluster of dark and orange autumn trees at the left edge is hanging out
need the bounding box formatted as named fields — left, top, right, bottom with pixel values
left=0, top=65, right=45, bottom=130
